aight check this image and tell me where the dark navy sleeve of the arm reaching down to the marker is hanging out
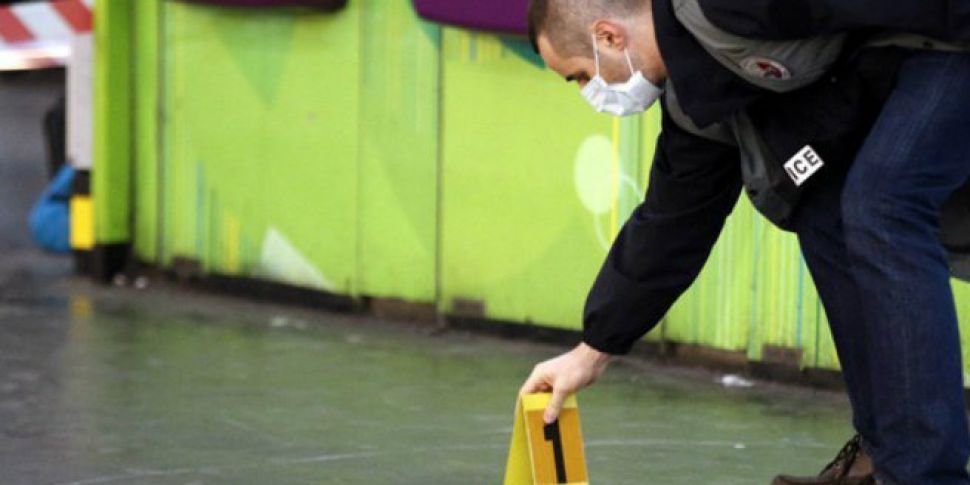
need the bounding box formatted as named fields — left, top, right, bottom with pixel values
left=583, top=108, right=741, bottom=354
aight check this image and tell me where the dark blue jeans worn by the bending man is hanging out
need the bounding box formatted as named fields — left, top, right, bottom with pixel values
left=795, top=52, right=970, bottom=485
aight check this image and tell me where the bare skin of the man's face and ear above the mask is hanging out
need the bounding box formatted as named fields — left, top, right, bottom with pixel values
left=537, top=34, right=631, bottom=89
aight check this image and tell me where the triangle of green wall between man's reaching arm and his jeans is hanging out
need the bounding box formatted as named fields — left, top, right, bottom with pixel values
left=665, top=199, right=835, bottom=367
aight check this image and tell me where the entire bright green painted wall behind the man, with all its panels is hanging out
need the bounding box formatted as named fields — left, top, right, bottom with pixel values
left=115, top=0, right=970, bottom=376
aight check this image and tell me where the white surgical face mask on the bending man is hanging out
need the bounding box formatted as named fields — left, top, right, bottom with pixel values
left=583, top=36, right=663, bottom=116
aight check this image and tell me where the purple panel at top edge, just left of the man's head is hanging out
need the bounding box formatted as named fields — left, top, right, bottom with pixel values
left=414, top=0, right=529, bottom=35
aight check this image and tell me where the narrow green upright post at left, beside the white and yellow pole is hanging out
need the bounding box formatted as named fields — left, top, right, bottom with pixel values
left=91, top=0, right=134, bottom=244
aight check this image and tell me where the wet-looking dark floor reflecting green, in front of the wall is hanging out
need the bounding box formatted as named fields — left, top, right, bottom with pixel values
left=0, top=70, right=851, bottom=485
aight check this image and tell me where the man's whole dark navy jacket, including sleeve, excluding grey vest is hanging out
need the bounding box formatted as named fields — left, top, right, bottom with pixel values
left=583, top=0, right=940, bottom=354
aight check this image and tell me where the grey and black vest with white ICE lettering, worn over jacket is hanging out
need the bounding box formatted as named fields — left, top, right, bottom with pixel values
left=664, top=0, right=970, bottom=279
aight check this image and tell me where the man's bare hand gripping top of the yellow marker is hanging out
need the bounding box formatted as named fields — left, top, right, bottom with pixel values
left=519, top=343, right=610, bottom=424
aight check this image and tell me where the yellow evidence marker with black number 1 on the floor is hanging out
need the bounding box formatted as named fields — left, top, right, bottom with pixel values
left=505, top=393, right=589, bottom=485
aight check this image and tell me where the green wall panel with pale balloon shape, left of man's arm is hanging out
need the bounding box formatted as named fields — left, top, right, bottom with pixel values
left=440, top=29, right=647, bottom=328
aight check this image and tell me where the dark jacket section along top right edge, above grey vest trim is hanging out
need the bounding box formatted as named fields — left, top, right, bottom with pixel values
left=699, top=0, right=970, bottom=42
